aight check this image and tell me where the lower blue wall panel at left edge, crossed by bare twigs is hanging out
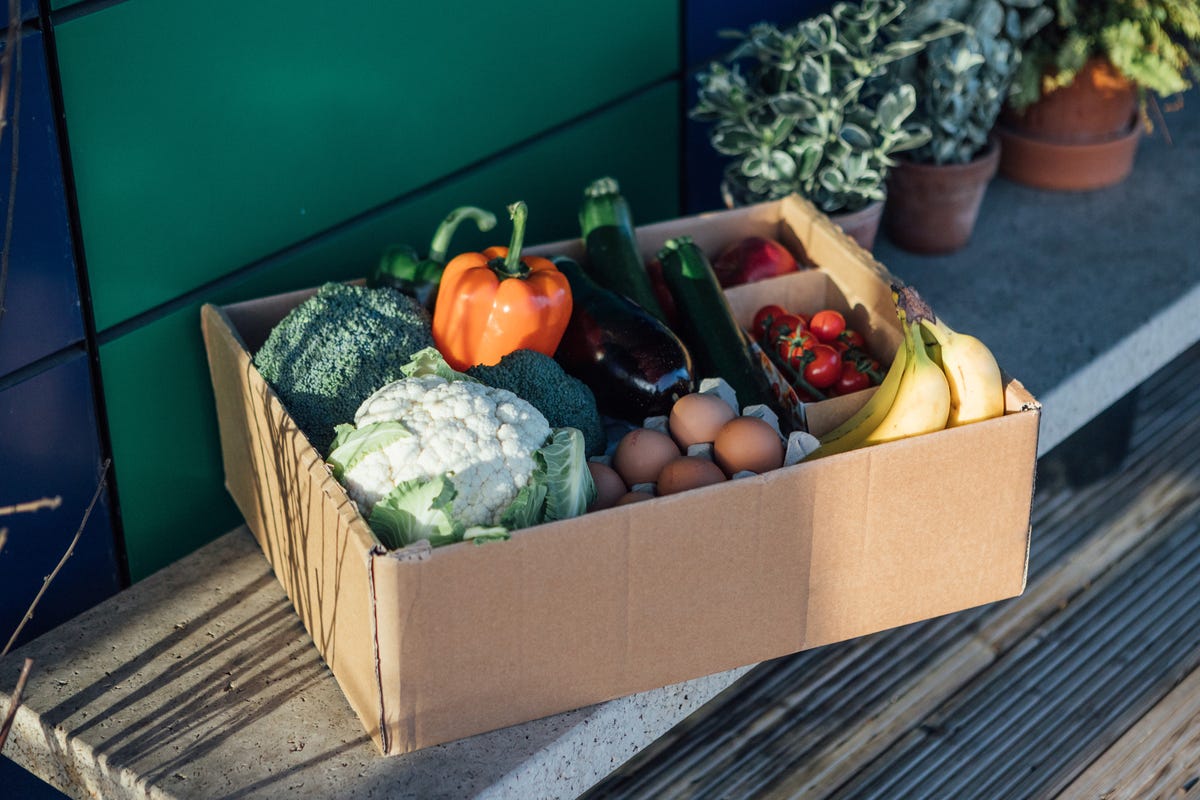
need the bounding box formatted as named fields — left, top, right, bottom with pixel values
left=0, top=353, right=120, bottom=646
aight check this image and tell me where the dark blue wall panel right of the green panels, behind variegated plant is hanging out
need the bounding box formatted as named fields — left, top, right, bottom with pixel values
left=683, top=0, right=833, bottom=213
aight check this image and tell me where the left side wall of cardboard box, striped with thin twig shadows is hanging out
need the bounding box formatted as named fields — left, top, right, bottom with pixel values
left=200, top=303, right=388, bottom=751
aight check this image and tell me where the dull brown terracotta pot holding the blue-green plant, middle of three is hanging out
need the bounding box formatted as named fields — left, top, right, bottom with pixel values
left=883, top=139, right=1001, bottom=254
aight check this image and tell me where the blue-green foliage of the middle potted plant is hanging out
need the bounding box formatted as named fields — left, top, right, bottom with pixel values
left=895, top=0, right=1052, bottom=164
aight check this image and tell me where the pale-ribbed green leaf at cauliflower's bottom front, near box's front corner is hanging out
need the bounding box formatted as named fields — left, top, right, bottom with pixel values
left=367, top=475, right=463, bottom=549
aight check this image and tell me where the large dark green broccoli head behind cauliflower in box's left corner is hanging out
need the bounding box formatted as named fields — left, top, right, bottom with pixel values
left=254, top=283, right=433, bottom=455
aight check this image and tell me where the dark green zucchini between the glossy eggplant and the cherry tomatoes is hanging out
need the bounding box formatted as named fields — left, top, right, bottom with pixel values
left=659, top=236, right=786, bottom=422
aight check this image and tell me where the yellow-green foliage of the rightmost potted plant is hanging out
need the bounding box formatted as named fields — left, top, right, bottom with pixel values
left=1010, top=0, right=1200, bottom=110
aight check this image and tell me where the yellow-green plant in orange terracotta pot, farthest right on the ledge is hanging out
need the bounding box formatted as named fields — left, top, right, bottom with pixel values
left=997, top=0, right=1200, bottom=190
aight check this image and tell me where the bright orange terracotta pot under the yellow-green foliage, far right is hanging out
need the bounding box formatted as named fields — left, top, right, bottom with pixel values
left=996, top=59, right=1141, bottom=192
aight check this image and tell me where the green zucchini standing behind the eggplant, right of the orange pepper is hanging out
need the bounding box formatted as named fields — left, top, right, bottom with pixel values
left=580, top=178, right=667, bottom=325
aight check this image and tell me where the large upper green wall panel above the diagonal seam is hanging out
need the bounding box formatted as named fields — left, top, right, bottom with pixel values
left=56, top=0, right=678, bottom=330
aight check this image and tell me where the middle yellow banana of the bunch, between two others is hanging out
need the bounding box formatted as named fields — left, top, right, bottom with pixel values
left=863, top=321, right=950, bottom=445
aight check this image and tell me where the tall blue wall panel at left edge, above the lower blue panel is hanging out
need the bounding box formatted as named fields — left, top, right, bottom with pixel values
left=0, top=32, right=84, bottom=375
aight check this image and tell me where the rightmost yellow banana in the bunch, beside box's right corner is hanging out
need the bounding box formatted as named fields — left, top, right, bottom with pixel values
left=922, top=318, right=1004, bottom=427
